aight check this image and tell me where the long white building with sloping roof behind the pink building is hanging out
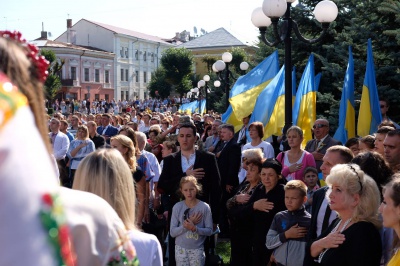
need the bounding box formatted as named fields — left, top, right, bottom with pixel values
left=55, top=19, right=174, bottom=100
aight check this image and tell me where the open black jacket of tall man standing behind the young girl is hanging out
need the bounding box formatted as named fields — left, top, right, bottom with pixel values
left=157, top=150, right=222, bottom=223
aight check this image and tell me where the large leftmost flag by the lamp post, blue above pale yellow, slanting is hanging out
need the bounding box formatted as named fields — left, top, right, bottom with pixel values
left=229, top=51, right=279, bottom=119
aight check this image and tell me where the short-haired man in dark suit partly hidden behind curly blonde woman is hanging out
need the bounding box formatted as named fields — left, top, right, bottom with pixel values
left=303, top=145, right=353, bottom=266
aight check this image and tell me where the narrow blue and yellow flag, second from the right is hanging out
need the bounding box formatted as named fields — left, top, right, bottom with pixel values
left=333, top=46, right=356, bottom=143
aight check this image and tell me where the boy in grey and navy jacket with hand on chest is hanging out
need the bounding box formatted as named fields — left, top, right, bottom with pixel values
left=266, top=180, right=311, bottom=266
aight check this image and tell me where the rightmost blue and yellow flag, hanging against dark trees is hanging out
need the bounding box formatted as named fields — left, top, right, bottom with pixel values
left=357, top=39, right=382, bottom=137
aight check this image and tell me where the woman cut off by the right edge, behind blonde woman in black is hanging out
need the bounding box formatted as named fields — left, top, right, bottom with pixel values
left=379, top=173, right=400, bottom=266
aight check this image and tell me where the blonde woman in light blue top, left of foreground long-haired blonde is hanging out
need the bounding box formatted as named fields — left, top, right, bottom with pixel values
left=67, top=125, right=96, bottom=186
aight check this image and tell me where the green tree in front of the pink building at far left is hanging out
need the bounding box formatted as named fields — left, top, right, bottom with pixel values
left=40, top=49, right=64, bottom=102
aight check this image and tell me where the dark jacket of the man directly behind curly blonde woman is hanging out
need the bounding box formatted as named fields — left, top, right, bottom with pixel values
left=303, top=187, right=328, bottom=266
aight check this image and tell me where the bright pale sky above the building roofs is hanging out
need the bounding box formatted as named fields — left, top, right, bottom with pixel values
left=0, top=0, right=298, bottom=44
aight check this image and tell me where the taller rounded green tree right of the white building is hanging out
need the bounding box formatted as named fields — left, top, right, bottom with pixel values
left=161, top=48, right=193, bottom=96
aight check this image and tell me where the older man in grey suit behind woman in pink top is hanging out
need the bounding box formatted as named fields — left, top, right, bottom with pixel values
left=305, top=119, right=342, bottom=173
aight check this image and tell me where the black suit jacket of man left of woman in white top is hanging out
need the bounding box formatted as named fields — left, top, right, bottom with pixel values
left=217, top=138, right=242, bottom=189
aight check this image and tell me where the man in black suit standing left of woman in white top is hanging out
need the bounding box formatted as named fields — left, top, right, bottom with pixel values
left=216, top=124, right=241, bottom=237
